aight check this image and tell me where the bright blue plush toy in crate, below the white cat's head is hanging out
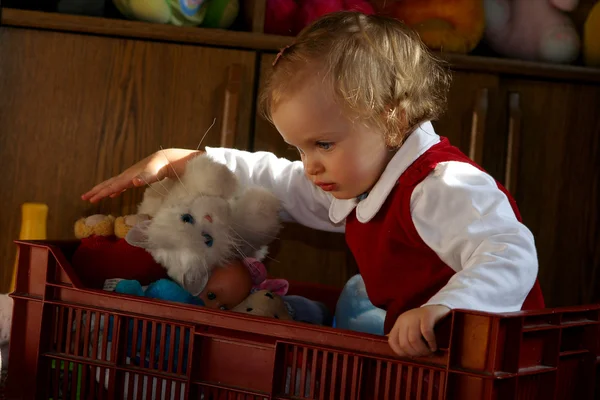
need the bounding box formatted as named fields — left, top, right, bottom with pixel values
left=109, top=279, right=204, bottom=373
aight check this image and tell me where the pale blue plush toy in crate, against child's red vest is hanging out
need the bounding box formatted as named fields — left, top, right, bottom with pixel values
left=334, top=275, right=386, bottom=335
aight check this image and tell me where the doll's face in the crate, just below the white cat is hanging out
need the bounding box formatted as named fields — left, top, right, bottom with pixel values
left=199, top=260, right=252, bottom=310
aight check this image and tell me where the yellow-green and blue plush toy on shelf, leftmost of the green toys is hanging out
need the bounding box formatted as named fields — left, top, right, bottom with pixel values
left=113, top=0, right=210, bottom=26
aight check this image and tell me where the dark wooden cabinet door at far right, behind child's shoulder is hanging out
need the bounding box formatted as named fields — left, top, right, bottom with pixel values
left=502, top=79, right=600, bottom=306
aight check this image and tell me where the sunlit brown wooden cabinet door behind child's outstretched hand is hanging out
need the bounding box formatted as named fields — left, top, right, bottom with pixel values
left=0, top=27, right=256, bottom=290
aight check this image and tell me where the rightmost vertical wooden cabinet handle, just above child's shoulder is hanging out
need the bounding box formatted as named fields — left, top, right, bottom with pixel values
left=504, top=93, right=521, bottom=196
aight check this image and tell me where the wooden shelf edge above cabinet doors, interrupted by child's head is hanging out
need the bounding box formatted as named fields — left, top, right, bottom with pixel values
left=0, top=8, right=600, bottom=84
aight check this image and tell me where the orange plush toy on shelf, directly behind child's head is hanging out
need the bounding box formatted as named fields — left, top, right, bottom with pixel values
left=373, top=0, right=485, bottom=53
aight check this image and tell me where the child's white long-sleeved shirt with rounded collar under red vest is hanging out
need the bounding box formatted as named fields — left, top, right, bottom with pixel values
left=206, top=123, right=538, bottom=312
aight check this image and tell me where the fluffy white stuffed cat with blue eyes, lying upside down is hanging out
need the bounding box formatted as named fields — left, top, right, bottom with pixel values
left=126, top=155, right=280, bottom=295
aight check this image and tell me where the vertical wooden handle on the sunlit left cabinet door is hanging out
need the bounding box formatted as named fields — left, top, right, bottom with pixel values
left=221, top=64, right=242, bottom=148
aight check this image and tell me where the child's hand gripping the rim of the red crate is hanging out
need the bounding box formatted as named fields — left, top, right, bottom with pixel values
left=388, top=305, right=450, bottom=357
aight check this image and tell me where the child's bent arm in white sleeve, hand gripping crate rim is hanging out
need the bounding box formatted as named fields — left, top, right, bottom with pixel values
left=389, top=162, right=538, bottom=356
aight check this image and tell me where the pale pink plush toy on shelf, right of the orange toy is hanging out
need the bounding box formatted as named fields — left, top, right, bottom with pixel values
left=484, top=0, right=580, bottom=64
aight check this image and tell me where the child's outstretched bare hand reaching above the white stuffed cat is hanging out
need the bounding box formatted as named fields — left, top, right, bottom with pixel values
left=81, top=149, right=202, bottom=203
